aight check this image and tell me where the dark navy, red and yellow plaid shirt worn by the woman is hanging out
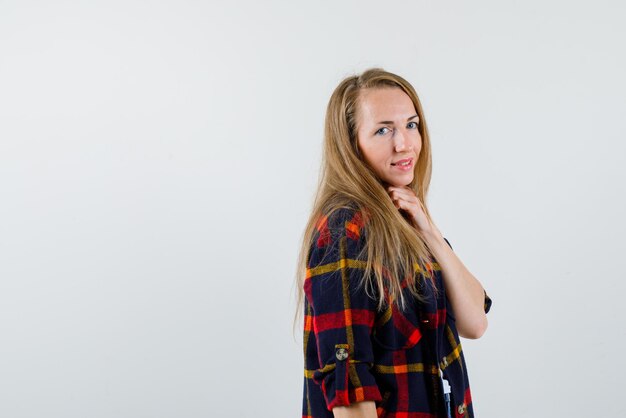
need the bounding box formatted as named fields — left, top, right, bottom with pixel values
left=302, top=209, right=491, bottom=418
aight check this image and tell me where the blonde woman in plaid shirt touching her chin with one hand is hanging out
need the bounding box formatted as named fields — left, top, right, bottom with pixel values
left=298, top=68, right=491, bottom=418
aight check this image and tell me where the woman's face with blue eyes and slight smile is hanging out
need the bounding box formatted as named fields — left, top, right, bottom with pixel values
left=357, top=87, right=422, bottom=187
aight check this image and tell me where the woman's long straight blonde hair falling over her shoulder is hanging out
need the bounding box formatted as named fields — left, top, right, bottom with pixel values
left=294, top=68, right=432, bottom=325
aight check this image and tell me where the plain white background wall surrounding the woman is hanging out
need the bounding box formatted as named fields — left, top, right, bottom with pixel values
left=0, top=0, right=626, bottom=418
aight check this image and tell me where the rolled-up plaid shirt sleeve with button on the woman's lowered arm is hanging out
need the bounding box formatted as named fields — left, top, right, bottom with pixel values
left=304, top=210, right=382, bottom=411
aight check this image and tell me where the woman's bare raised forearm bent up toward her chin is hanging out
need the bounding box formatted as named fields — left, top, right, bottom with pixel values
left=424, top=225, right=487, bottom=338
